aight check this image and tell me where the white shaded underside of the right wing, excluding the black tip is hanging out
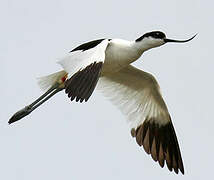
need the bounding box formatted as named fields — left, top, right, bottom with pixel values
left=98, top=65, right=170, bottom=128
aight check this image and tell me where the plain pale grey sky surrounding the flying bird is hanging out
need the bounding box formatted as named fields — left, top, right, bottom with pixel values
left=0, top=0, right=214, bottom=180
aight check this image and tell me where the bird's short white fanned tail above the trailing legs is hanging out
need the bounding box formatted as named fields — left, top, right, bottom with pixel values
left=37, top=71, right=67, bottom=91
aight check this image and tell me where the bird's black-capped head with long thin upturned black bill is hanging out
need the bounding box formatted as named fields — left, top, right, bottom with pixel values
left=135, top=31, right=197, bottom=51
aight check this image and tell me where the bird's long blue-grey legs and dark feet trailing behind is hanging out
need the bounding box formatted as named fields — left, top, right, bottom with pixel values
left=8, top=82, right=64, bottom=124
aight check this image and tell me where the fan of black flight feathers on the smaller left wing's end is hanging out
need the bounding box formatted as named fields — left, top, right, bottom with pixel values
left=65, top=62, right=103, bottom=102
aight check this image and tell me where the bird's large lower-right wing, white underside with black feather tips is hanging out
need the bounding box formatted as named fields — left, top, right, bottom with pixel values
left=98, top=65, right=184, bottom=173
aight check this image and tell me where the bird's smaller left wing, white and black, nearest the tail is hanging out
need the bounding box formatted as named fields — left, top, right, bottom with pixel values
left=58, top=39, right=109, bottom=102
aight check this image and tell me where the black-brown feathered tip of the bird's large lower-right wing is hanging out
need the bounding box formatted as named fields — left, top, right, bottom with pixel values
left=131, top=119, right=184, bottom=174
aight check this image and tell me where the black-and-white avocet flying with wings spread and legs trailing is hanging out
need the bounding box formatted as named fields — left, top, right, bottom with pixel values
left=8, top=31, right=196, bottom=174
